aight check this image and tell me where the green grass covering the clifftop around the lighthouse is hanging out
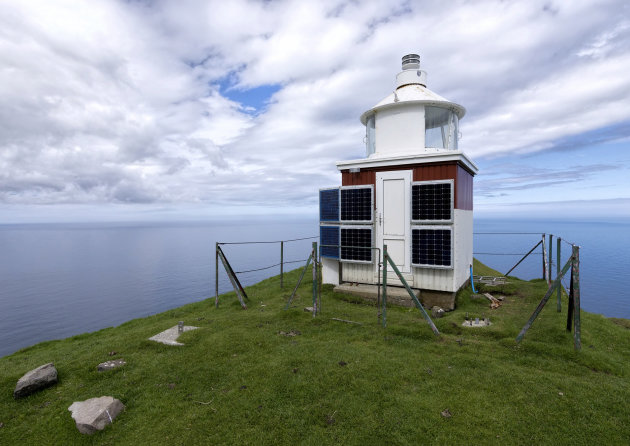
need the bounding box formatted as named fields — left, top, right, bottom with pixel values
left=0, top=264, right=630, bottom=445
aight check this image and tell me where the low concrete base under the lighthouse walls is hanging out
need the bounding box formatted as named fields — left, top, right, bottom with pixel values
left=334, top=282, right=455, bottom=311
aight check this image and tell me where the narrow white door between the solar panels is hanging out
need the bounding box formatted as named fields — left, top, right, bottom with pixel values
left=376, top=170, right=411, bottom=273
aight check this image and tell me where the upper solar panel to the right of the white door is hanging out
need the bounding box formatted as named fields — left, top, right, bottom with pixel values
left=411, top=180, right=453, bottom=223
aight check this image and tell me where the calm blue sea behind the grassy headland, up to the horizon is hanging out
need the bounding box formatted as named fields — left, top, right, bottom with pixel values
left=0, top=218, right=630, bottom=356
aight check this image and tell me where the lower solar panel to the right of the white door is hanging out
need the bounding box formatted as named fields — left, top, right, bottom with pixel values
left=411, top=226, right=453, bottom=268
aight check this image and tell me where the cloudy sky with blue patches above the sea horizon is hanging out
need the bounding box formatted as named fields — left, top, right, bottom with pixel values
left=0, top=0, right=630, bottom=223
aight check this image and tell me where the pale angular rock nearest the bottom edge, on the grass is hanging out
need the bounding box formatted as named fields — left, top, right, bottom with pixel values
left=68, top=396, right=125, bottom=435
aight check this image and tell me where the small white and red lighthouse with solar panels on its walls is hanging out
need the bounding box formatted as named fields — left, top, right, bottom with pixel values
left=319, top=54, right=478, bottom=309
